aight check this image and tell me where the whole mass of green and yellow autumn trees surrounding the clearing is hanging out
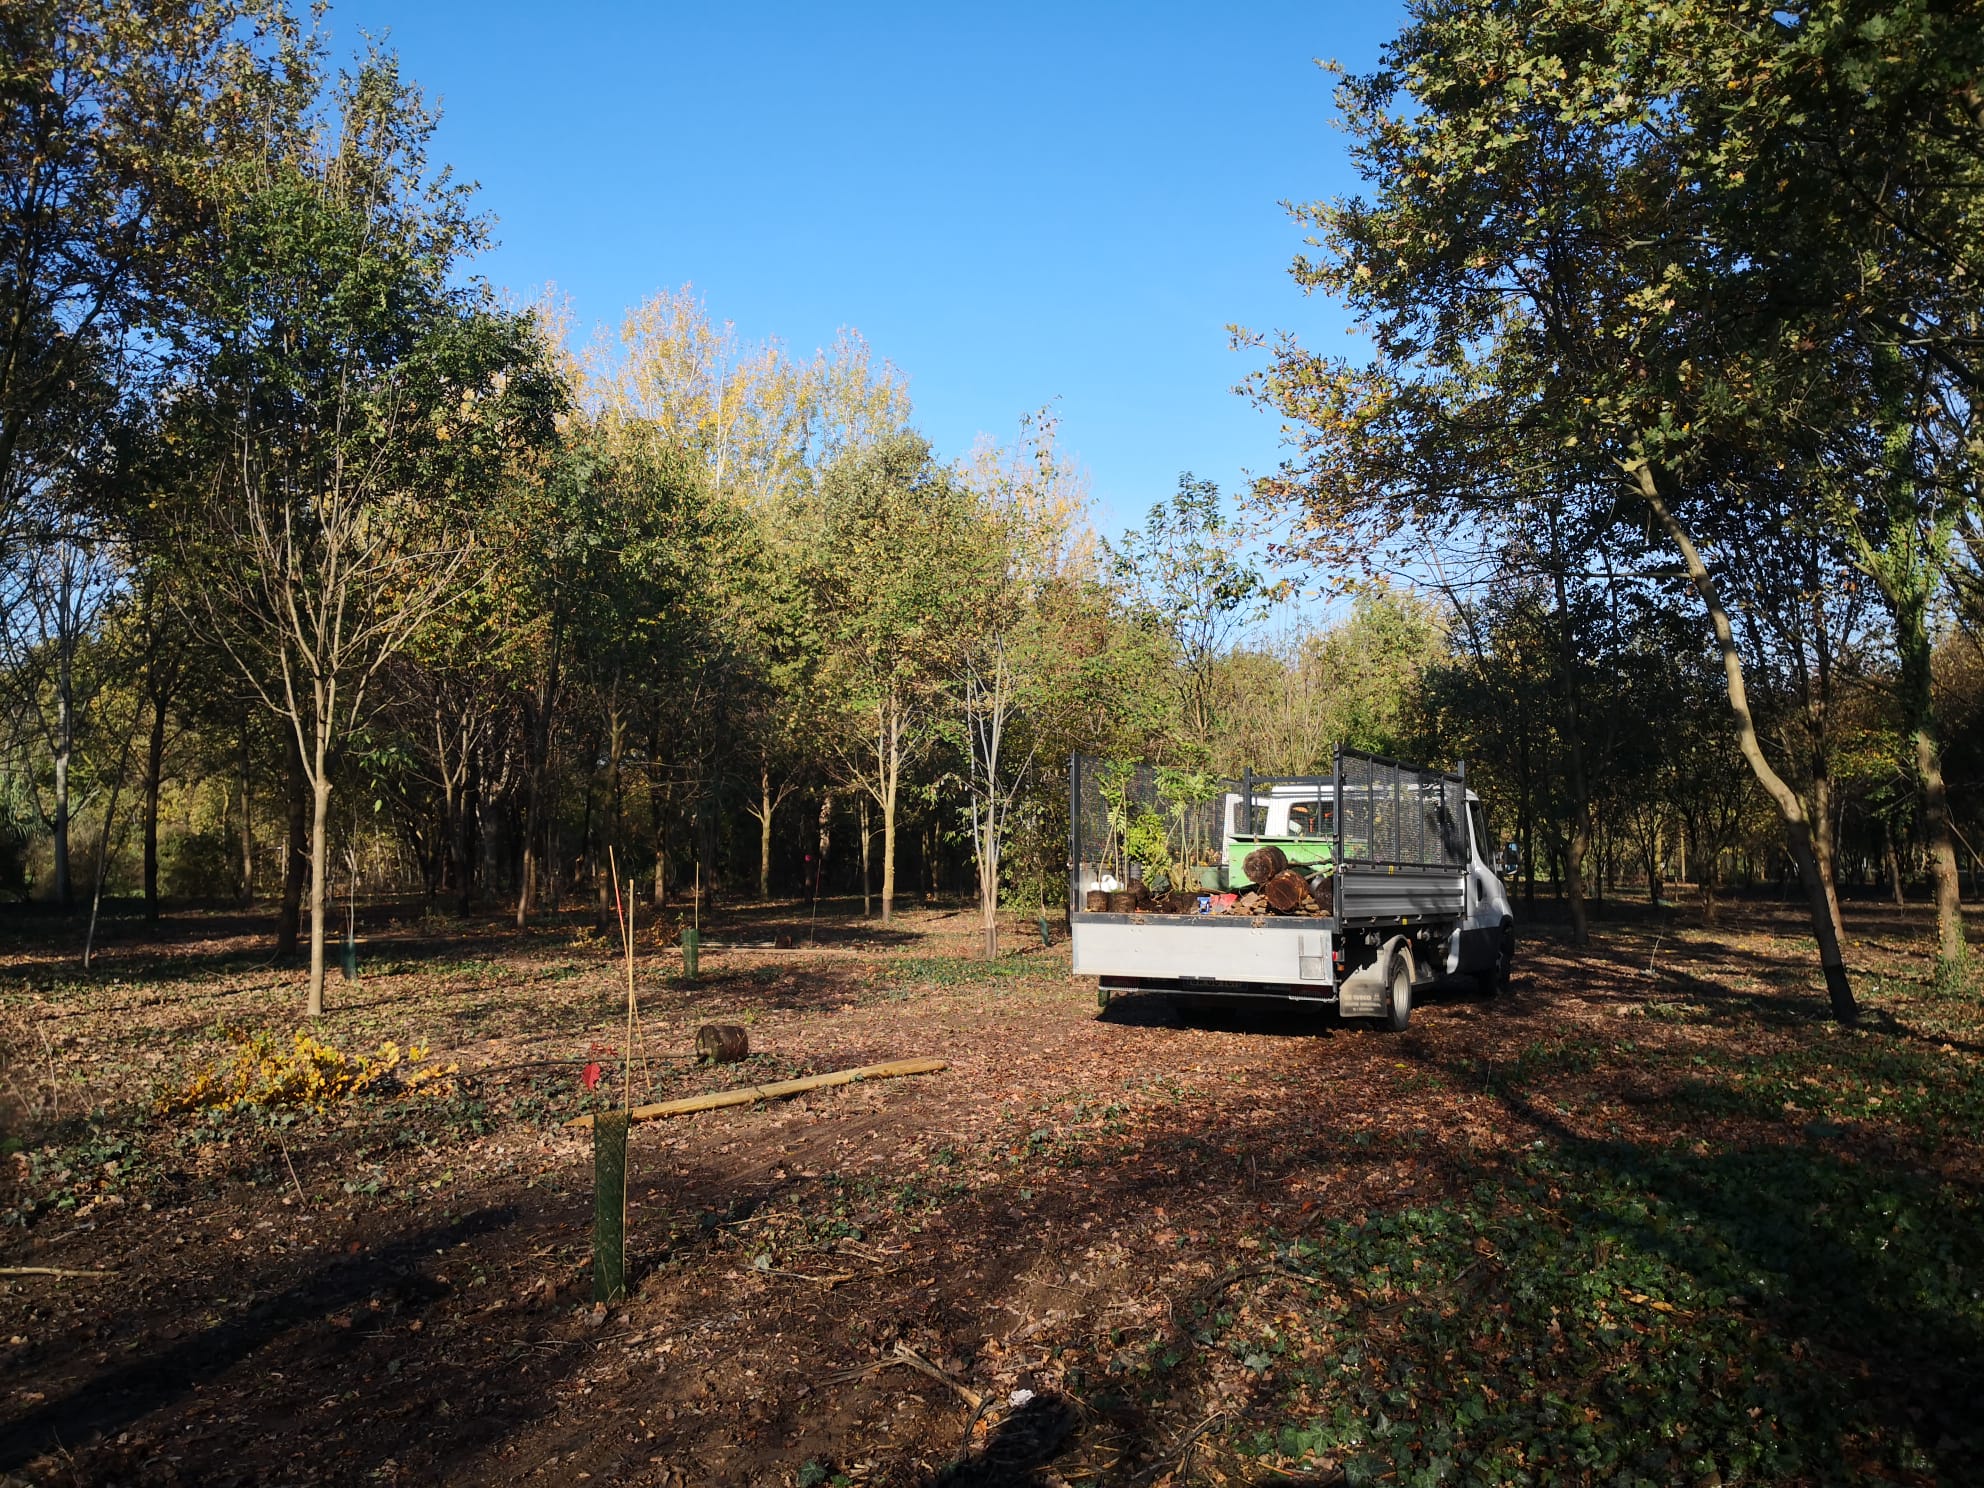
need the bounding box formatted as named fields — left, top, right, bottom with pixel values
left=0, top=0, right=1984, bottom=1014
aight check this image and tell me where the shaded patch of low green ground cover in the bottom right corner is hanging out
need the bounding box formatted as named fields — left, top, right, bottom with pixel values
left=1200, top=1145, right=1984, bottom=1488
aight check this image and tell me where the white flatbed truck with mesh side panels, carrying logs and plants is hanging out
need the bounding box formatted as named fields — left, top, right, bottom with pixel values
left=1067, top=748, right=1516, bottom=1030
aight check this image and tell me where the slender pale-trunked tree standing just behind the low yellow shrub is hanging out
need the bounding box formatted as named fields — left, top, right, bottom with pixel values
left=185, top=54, right=558, bottom=1016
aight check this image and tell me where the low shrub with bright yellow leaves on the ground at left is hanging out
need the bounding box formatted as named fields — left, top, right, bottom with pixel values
left=153, top=1030, right=456, bottom=1115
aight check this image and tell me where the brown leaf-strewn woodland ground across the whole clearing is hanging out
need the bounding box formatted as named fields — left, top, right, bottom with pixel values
left=0, top=905, right=1984, bottom=1488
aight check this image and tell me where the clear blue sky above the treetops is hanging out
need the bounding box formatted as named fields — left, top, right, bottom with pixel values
left=329, top=0, right=1401, bottom=532
